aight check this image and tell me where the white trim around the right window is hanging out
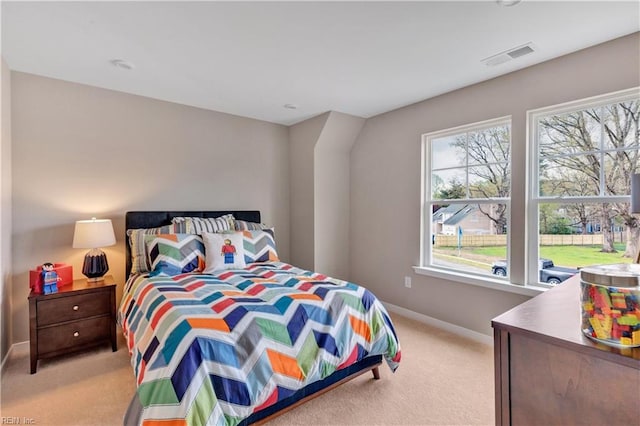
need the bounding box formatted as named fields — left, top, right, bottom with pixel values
left=525, top=87, right=640, bottom=282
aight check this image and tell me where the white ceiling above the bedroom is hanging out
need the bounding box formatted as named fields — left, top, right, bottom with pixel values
left=2, top=0, right=640, bottom=125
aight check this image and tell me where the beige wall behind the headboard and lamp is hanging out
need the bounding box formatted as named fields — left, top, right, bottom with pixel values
left=11, top=72, right=289, bottom=343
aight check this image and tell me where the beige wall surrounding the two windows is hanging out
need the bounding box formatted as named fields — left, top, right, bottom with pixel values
left=351, top=33, right=640, bottom=335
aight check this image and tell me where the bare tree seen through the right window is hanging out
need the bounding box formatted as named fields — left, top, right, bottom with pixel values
left=539, top=100, right=640, bottom=257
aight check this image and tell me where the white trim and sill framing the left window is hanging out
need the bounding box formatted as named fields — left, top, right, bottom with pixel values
left=420, top=115, right=516, bottom=296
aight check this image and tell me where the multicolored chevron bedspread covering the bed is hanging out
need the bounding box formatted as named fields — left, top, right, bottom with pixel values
left=119, top=262, right=400, bottom=425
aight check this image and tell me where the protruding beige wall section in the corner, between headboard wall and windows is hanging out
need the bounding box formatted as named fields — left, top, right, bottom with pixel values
left=289, top=111, right=365, bottom=280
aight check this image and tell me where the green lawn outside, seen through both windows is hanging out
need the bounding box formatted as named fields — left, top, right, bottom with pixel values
left=470, top=244, right=632, bottom=268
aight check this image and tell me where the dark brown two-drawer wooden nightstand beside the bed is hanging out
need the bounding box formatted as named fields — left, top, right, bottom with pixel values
left=29, top=275, right=118, bottom=374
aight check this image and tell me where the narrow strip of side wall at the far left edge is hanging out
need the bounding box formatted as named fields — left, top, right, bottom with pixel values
left=0, top=59, right=13, bottom=360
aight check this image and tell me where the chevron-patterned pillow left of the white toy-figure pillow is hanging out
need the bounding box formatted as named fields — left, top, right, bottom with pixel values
left=144, top=234, right=205, bottom=276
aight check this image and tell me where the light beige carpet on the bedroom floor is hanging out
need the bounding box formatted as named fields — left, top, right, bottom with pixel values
left=0, top=315, right=494, bottom=425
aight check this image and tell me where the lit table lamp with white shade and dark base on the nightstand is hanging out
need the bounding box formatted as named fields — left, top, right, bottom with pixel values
left=73, top=217, right=116, bottom=282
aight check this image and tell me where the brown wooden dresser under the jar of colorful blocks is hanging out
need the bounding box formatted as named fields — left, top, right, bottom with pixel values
left=491, top=276, right=640, bottom=425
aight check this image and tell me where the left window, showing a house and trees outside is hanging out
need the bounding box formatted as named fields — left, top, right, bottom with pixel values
left=422, top=118, right=511, bottom=277
